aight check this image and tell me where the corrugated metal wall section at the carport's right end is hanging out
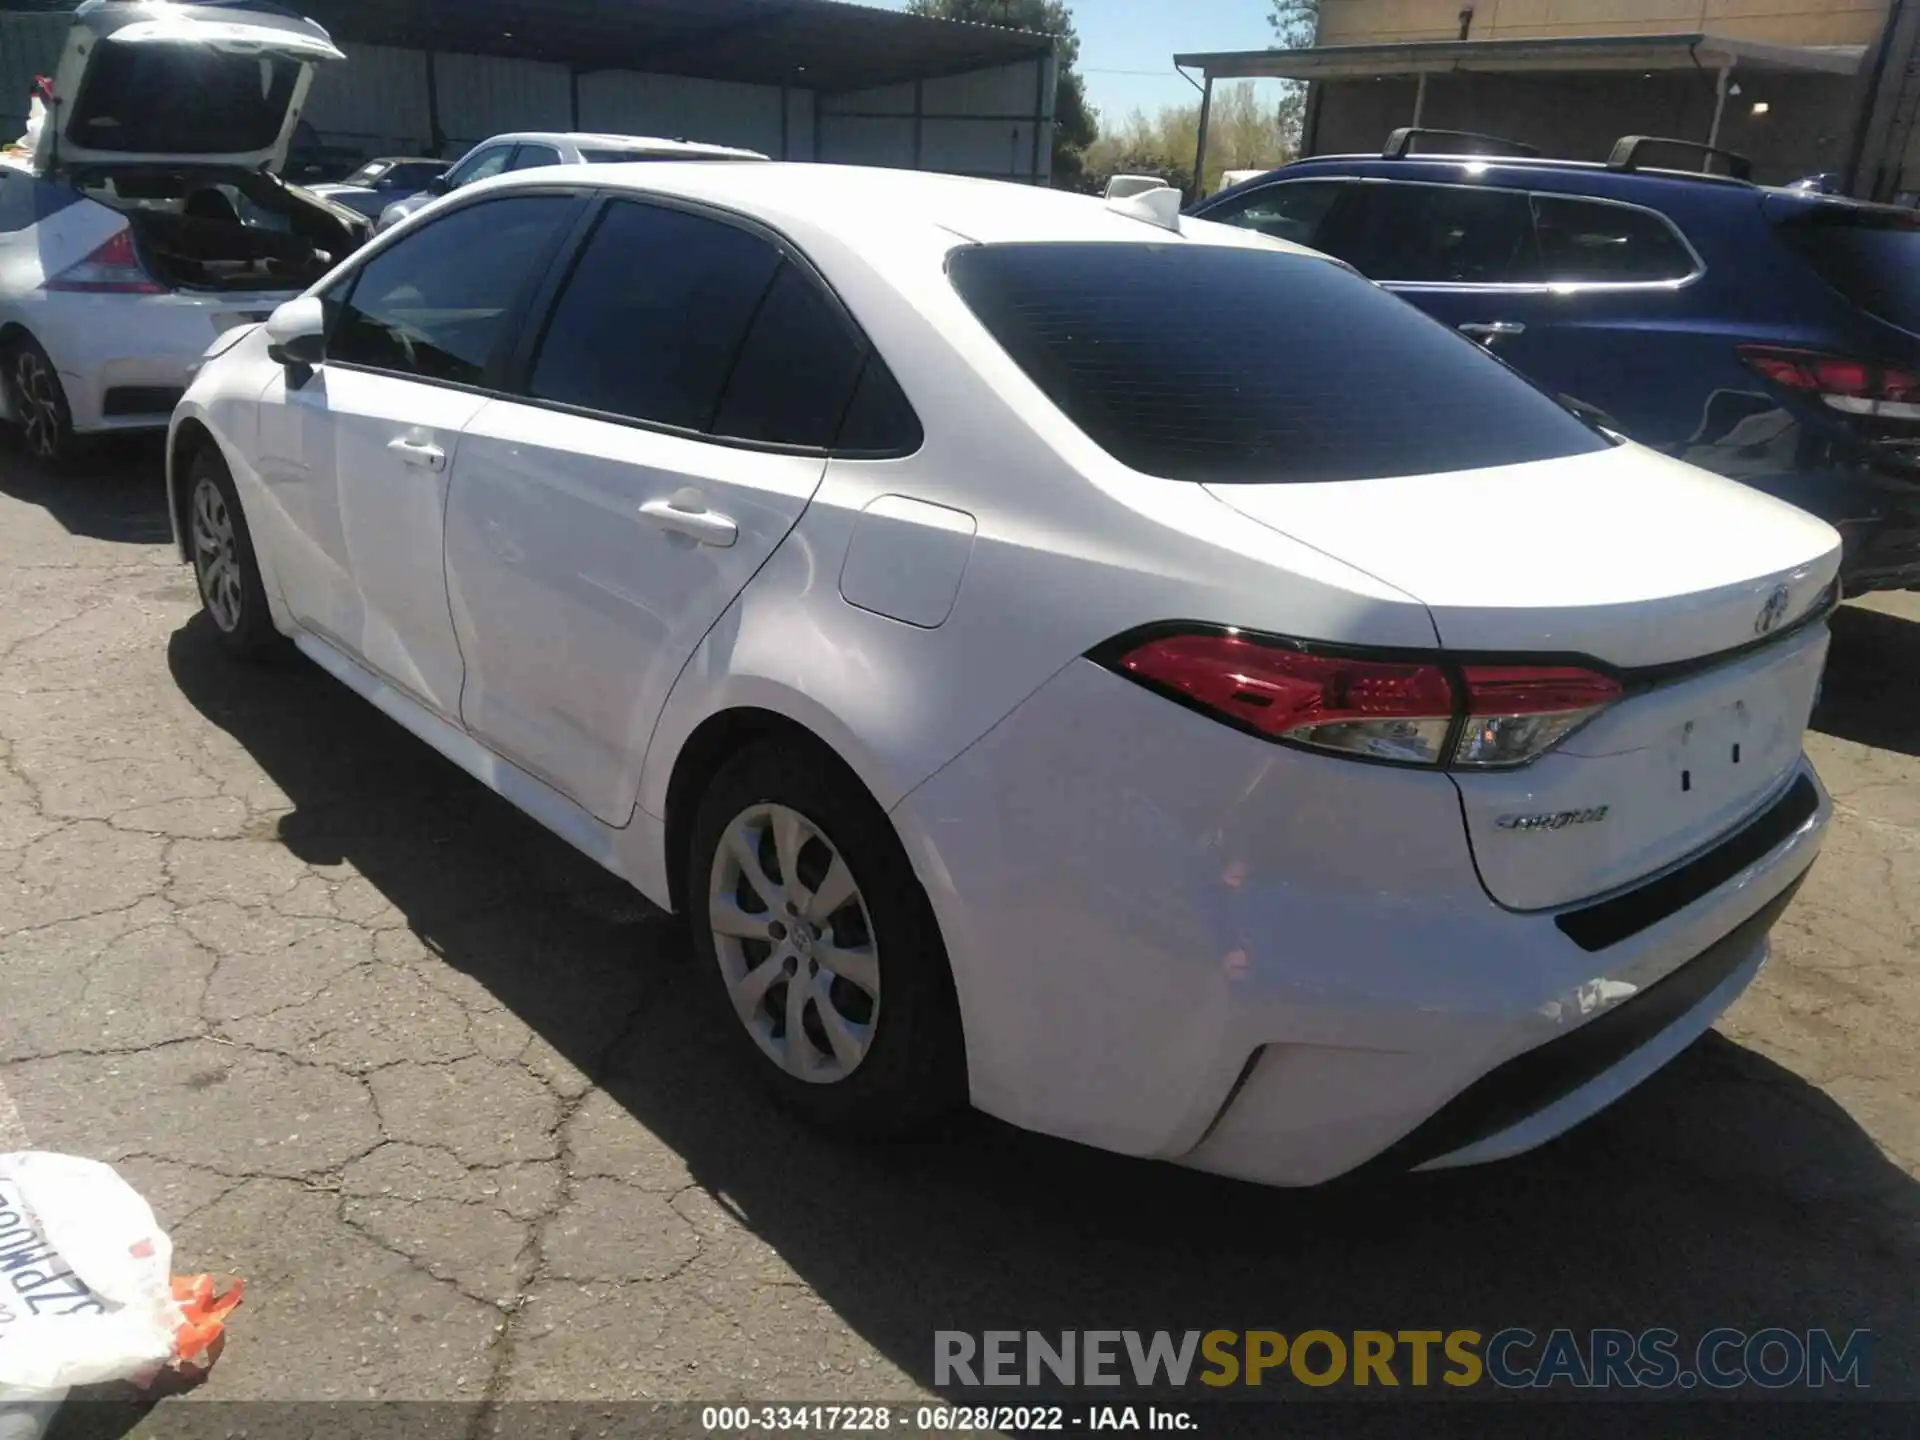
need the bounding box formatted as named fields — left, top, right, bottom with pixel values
left=818, top=60, right=1056, bottom=184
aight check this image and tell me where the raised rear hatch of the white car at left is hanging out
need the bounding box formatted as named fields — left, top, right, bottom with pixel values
left=35, top=0, right=346, bottom=171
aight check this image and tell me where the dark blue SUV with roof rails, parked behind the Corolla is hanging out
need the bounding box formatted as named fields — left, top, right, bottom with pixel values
left=1190, top=131, right=1920, bottom=593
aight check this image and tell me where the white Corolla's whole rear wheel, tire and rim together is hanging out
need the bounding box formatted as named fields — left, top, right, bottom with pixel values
left=685, top=741, right=966, bottom=1139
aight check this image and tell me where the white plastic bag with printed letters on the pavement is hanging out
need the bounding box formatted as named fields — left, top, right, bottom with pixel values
left=0, top=1152, right=180, bottom=1440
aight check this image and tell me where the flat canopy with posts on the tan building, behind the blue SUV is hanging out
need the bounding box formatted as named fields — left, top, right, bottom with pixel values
left=1173, top=31, right=1866, bottom=192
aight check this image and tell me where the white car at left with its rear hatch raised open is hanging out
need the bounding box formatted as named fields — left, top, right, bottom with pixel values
left=0, top=0, right=369, bottom=461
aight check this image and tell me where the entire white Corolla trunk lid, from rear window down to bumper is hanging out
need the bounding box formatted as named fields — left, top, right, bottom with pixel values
left=1210, top=445, right=1839, bottom=910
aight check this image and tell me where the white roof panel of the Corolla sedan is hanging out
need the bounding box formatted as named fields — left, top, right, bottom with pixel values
left=470, top=161, right=1317, bottom=255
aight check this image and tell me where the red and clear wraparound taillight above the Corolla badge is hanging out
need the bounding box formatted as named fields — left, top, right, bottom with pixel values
left=1104, top=628, right=1620, bottom=770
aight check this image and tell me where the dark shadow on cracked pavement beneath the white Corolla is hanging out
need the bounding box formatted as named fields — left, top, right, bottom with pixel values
left=153, top=618, right=1920, bottom=1430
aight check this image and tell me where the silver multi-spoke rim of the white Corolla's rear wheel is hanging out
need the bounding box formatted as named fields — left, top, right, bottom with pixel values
left=707, top=804, right=879, bottom=1085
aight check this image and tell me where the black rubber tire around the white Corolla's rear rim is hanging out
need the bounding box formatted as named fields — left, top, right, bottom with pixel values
left=685, top=739, right=966, bottom=1139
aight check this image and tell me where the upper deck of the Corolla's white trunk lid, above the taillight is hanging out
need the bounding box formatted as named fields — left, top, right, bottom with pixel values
left=1208, top=445, right=1839, bottom=668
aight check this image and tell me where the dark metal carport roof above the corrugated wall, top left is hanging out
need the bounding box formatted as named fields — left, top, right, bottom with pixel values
left=286, top=0, right=1054, bottom=92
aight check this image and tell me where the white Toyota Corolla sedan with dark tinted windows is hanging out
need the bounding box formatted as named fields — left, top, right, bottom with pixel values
left=169, top=163, right=1839, bottom=1185
